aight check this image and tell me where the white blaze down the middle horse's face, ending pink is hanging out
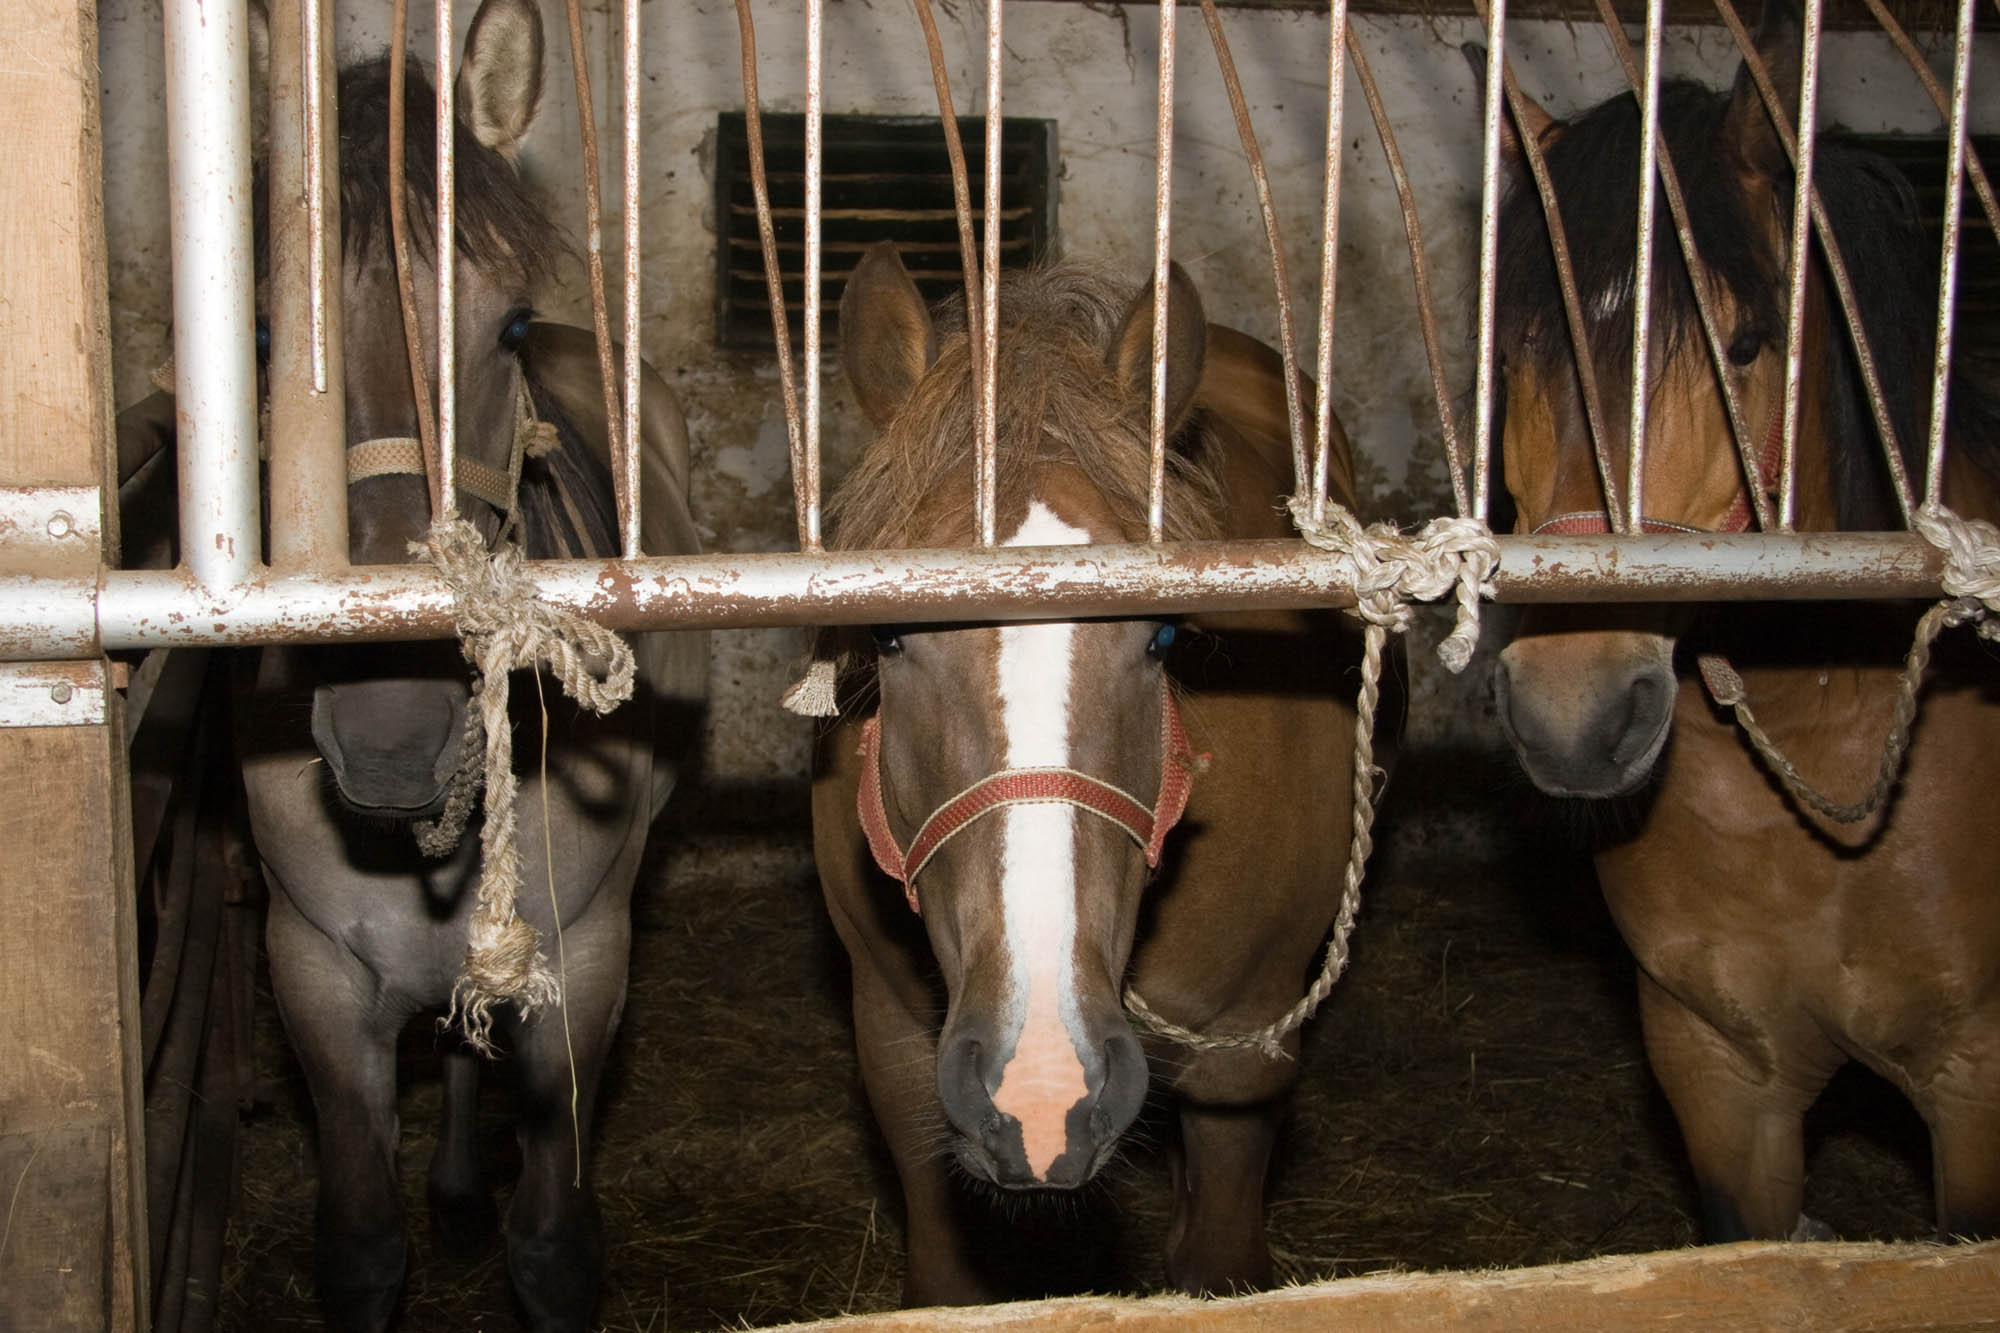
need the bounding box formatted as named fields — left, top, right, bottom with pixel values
left=994, top=500, right=1090, bottom=1177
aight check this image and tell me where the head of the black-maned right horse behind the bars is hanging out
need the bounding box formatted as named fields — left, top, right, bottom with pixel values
left=1496, top=0, right=1896, bottom=797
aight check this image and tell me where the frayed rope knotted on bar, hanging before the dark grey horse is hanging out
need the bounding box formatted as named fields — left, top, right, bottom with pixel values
left=410, top=518, right=636, bottom=1053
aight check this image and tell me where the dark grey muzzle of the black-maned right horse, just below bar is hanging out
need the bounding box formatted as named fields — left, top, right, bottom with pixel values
left=1494, top=650, right=1674, bottom=799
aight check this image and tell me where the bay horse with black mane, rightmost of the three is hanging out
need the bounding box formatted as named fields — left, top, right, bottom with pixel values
left=1496, top=0, right=2000, bottom=1241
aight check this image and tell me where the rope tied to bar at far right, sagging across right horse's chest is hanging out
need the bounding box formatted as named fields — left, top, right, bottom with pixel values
left=1696, top=504, right=2000, bottom=825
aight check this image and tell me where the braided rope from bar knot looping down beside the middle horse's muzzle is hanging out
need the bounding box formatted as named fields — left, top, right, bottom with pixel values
left=1124, top=496, right=1500, bottom=1061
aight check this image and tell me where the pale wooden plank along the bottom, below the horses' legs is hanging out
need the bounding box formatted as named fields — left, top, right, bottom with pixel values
left=772, top=1241, right=2000, bottom=1333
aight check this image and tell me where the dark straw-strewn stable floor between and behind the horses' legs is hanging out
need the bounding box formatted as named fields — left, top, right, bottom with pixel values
left=222, top=740, right=1930, bottom=1333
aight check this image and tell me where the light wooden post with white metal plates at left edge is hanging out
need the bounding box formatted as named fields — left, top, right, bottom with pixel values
left=0, top=0, right=146, bottom=1333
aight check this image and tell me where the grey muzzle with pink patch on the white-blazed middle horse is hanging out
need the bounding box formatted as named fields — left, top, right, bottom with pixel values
left=938, top=1019, right=1146, bottom=1189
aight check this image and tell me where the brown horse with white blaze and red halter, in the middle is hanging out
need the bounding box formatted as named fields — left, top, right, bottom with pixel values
left=812, top=244, right=1358, bottom=1305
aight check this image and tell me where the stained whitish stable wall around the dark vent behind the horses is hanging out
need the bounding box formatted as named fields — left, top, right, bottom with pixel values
left=102, top=0, right=2000, bottom=781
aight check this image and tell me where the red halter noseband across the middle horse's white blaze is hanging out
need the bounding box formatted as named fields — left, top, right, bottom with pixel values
left=854, top=679, right=1198, bottom=913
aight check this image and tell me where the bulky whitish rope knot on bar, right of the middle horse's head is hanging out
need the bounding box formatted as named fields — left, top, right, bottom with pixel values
left=1290, top=496, right=1500, bottom=675
